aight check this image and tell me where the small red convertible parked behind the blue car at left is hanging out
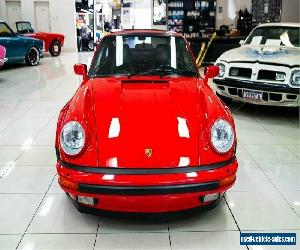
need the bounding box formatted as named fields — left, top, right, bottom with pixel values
left=16, top=21, right=65, bottom=56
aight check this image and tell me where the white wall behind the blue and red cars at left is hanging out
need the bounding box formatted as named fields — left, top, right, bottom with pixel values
left=0, top=0, right=77, bottom=51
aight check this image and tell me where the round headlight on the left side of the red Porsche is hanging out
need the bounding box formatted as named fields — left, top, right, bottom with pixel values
left=60, top=121, right=85, bottom=155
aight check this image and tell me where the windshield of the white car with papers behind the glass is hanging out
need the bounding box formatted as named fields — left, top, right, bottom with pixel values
left=245, top=26, right=300, bottom=48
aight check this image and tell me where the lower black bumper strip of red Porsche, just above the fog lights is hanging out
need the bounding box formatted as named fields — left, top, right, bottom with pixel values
left=78, top=181, right=219, bottom=195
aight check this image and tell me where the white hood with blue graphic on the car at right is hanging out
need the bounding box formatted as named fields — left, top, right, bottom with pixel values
left=219, top=45, right=300, bottom=66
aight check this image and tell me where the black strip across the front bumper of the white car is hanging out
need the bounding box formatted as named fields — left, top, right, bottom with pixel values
left=213, top=78, right=300, bottom=95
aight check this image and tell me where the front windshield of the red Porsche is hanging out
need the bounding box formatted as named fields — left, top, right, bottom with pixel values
left=89, top=34, right=198, bottom=77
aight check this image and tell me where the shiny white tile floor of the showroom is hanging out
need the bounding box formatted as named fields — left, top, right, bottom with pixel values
left=0, top=53, right=300, bottom=250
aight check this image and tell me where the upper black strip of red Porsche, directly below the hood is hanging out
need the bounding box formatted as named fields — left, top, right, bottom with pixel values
left=59, top=156, right=235, bottom=175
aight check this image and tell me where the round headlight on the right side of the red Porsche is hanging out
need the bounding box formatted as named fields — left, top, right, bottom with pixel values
left=210, top=119, right=234, bottom=153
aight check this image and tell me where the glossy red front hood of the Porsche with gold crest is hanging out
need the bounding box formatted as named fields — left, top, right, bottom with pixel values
left=91, top=78, right=201, bottom=168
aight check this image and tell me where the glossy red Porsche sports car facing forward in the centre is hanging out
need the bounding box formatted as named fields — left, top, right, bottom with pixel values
left=55, top=30, right=238, bottom=213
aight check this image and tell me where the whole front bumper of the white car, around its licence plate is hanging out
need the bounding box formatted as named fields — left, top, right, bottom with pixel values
left=213, top=78, right=300, bottom=107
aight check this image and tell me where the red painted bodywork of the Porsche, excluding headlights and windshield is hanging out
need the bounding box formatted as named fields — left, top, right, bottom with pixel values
left=55, top=31, right=238, bottom=213
